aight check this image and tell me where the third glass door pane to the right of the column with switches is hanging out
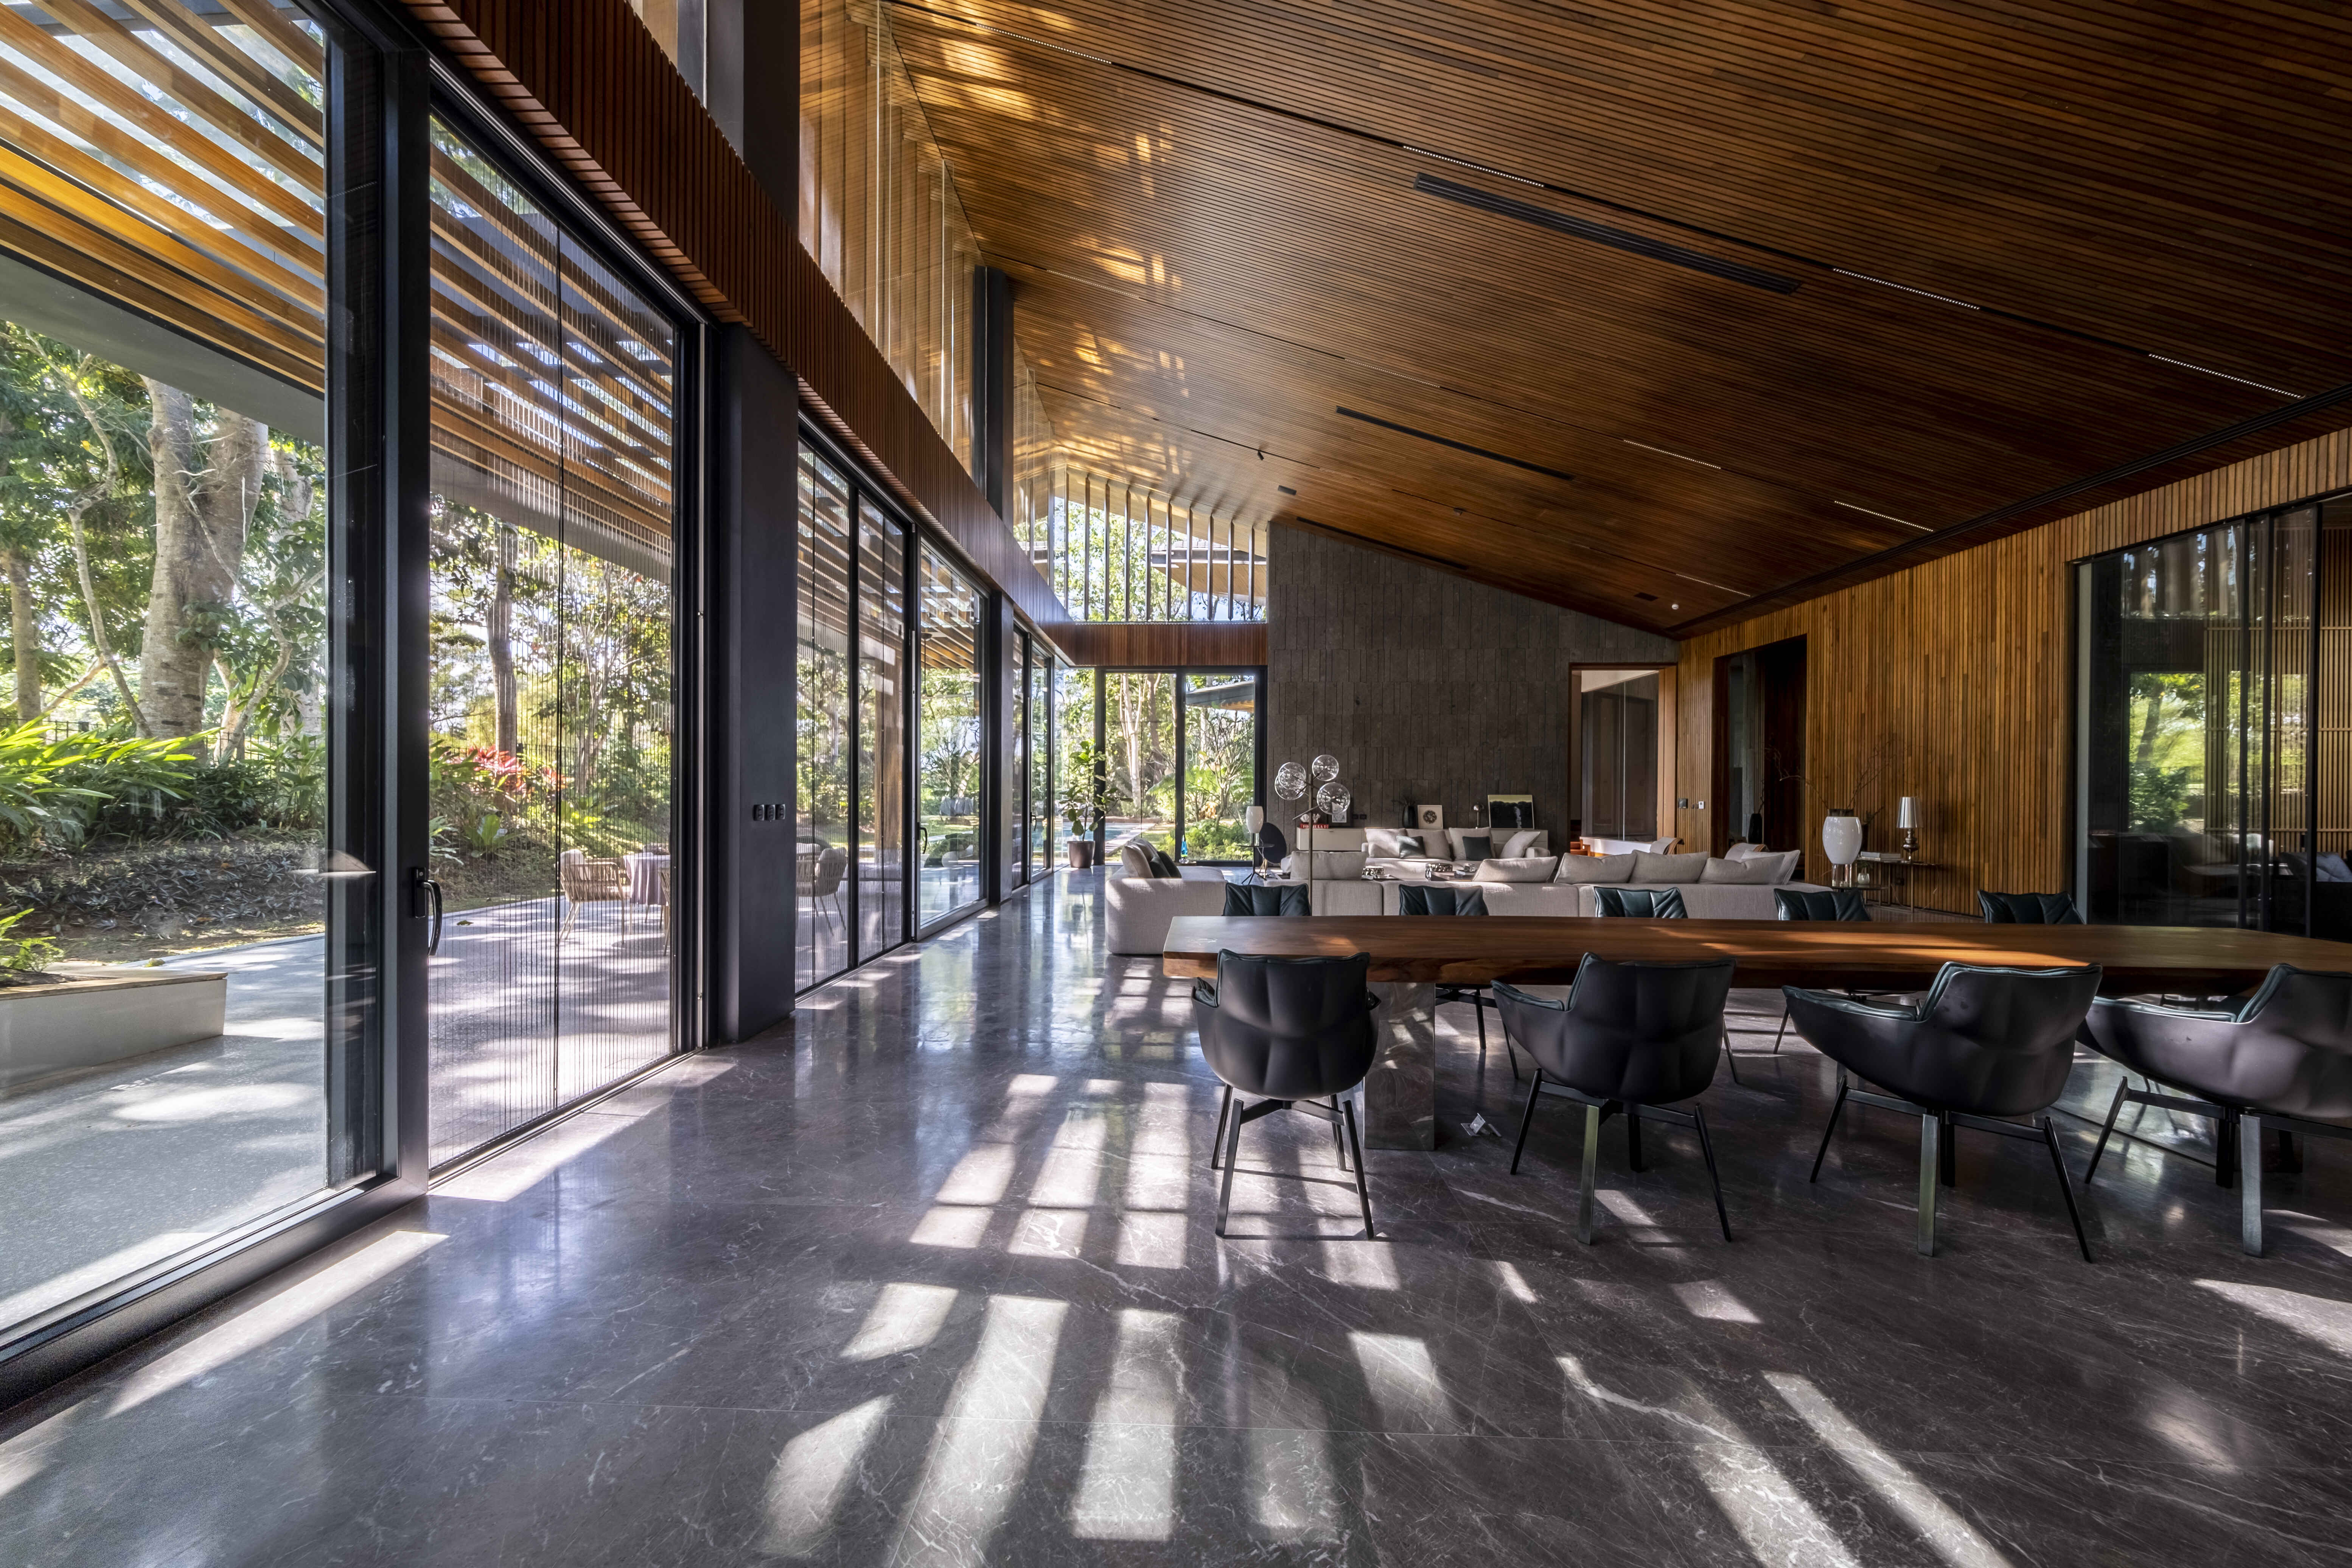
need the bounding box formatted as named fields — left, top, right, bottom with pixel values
left=915, top=541, right=986, bottom=926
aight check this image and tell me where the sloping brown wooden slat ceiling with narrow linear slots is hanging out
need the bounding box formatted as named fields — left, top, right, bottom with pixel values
left=887, top=0, right=2352, bottom=630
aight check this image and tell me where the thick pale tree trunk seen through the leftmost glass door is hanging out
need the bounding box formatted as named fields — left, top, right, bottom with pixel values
left=139, top=381, right=270, bottom=736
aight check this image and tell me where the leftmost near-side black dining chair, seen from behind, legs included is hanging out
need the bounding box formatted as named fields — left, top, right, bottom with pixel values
left=1192, top=952, right=1380, bottom=1239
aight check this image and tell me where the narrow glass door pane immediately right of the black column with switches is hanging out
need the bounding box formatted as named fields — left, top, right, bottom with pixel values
left=793, top=449, right=854, bottom=990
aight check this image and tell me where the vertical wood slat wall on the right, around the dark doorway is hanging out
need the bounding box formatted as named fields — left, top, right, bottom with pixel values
left=1675, top=430, right=2352, bottom=914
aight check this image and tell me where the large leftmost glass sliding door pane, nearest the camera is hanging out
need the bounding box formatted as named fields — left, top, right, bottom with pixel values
left=0, top=0, right=388, bottom=1354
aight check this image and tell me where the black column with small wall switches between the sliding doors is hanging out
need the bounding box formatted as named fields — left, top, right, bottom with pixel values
left=706, top=327, right=800, bottom=1041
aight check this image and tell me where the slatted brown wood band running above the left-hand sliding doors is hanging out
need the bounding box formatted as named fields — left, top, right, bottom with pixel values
left=407, top=0, right=1068, bottom=635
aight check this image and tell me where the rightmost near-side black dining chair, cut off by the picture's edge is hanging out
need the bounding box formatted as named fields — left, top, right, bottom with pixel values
left=2082, top=964, right=2352, bottom=1258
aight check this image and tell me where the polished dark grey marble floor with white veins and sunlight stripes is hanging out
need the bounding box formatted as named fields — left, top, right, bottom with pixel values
left=0, top=875, right=2352, bottom=1568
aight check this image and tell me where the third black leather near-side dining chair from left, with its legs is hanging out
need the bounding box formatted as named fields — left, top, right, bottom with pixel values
left=1783, top=964, right=2100, bottom=1262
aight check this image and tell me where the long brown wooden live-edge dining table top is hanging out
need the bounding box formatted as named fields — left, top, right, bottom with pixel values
left=1162, top=914, right=2352, bottom=995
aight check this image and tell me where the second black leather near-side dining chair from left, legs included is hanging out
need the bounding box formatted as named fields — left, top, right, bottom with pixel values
left=1494, top=952, right=1733, bottom=1246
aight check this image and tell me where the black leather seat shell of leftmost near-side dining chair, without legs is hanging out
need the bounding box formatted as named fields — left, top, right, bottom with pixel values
left=1192, top=952, right=1380, bottom=1100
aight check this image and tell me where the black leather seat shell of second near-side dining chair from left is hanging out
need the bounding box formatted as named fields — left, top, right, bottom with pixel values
left=1494, top=952, right=1733, bottom=1105
